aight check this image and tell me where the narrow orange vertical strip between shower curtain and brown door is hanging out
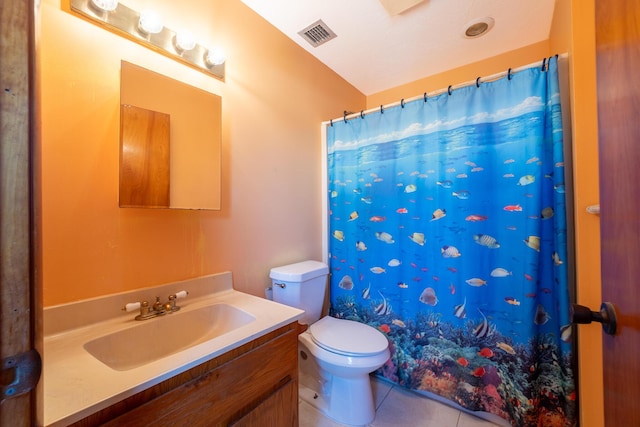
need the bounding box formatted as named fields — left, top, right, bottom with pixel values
left=568, top=0, right=604, bottom=427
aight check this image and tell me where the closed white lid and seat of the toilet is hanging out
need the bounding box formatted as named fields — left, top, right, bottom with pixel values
left=309, top=316, right=389, bottom=357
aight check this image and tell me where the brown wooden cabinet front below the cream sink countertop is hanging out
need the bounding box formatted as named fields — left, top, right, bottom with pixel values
left=74, top=322, right=298, bottom=427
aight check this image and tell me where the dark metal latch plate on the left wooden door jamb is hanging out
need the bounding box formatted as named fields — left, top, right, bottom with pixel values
left=0, top=350, right=42, bottom=403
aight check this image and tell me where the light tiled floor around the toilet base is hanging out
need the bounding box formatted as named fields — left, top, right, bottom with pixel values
left=300, top=378, right=496, bottom=427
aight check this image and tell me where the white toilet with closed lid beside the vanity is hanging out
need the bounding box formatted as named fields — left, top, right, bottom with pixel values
left=270, top=261, right=390, bottom=426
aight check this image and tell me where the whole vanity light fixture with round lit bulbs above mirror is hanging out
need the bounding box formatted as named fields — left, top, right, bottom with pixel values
left=70, top=0, right=225, bottom=80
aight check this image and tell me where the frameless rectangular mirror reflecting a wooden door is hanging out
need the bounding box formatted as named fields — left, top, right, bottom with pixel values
left=119, top=61, right=222, bottom=210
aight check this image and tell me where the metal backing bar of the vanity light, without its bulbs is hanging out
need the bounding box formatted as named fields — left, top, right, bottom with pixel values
left=71, top=0, right=225, bottom=80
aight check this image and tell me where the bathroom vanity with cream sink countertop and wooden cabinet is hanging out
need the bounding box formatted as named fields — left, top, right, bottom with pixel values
left=43, top=273, right=302, bottom=426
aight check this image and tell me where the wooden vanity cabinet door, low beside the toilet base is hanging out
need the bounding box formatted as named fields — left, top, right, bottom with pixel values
left=230, top=380, right=298, bottom=427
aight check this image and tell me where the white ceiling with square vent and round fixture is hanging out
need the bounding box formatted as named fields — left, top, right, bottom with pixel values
left=242, top=0, right=556, bottom=95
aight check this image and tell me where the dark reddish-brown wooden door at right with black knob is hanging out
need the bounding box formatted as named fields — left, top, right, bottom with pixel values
left=596, top=0, right=640, bottom=427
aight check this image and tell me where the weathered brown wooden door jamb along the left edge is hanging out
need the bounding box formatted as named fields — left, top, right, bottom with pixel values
left=0, top=0, right=39, bottom=427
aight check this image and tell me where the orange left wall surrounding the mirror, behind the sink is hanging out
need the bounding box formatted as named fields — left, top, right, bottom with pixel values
left=37, top=0, right=365, bottom=309
